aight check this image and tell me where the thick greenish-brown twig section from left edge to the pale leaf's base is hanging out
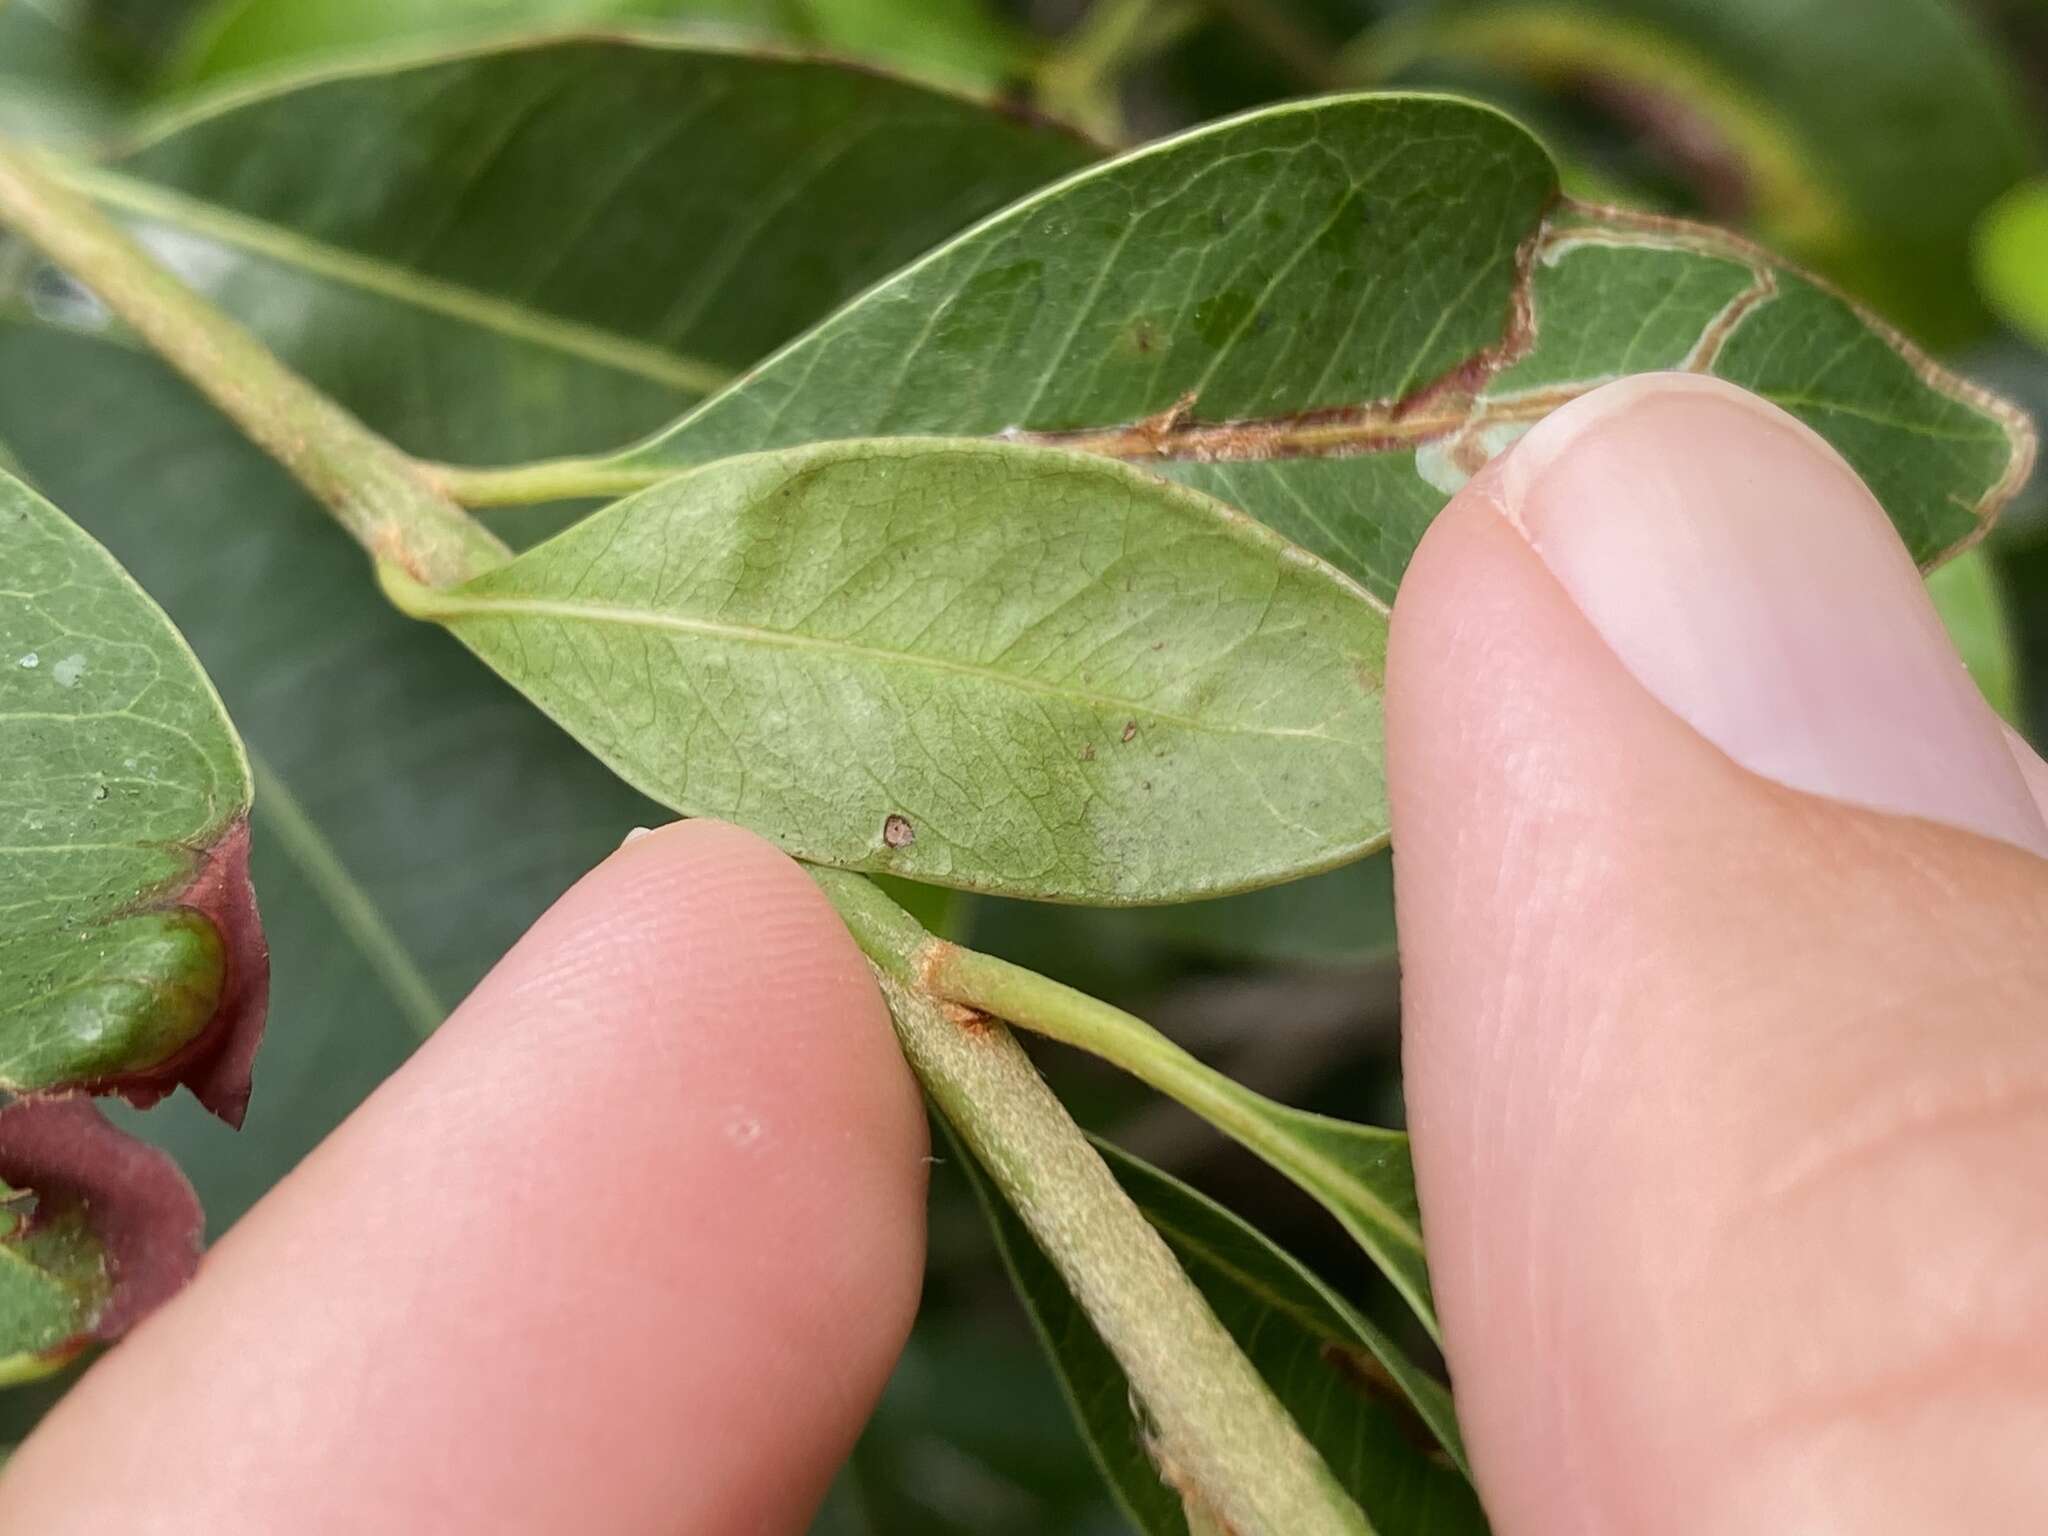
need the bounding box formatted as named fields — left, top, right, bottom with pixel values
left=0, top=143, right=508, bottom=586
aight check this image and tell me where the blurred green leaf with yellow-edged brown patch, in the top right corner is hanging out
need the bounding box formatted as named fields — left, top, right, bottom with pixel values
left=1409, top=0, right=2032, bottom=344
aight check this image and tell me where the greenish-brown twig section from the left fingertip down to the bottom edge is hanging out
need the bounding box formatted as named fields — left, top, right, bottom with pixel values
left=811, top=868, right=1370, bottom=1536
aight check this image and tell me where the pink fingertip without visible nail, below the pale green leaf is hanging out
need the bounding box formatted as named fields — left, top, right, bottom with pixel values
left=0, top=823, right=926, bottom=1534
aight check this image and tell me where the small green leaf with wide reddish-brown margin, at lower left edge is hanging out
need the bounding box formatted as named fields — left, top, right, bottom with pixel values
left=0, top=1098, right=203, bottom=1386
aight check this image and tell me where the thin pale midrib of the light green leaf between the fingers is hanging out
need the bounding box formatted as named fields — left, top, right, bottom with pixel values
left=421, top=592, right=1346, bottom=745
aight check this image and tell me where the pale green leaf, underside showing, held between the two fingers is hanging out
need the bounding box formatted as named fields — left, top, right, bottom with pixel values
left=387, top=440, right=1386, bottom=903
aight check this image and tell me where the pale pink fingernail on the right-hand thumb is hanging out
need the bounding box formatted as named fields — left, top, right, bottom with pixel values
left=1493, top=375, right=2048, bottom=852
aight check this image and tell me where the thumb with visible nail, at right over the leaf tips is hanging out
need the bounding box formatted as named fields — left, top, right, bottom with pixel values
left=1389, top=377, right=2048, bottom=1536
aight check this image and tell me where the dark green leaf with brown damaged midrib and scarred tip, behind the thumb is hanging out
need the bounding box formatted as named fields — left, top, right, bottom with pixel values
left=585, top=96, right=2030, bottom=596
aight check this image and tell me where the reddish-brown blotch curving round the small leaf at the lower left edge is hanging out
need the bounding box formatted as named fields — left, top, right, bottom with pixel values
left=0, top=1094, right=205, bottom=1352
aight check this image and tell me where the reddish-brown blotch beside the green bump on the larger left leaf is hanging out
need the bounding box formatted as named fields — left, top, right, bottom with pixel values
left=86, top=819, right=270, bottom=1130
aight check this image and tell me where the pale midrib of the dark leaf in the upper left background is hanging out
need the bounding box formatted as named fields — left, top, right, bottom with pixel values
left=57, top=162, right=737, bottom=395
